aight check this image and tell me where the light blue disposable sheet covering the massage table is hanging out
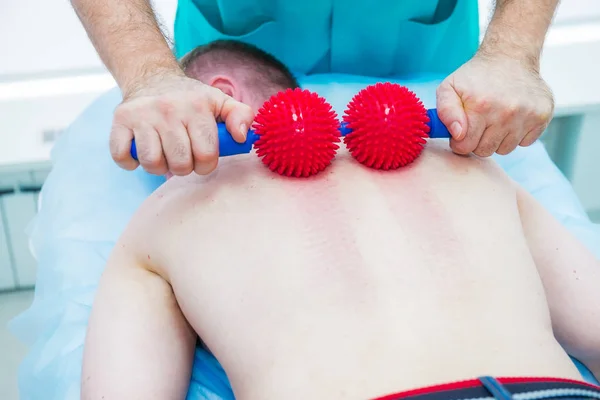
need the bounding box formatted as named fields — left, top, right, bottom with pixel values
left=11, top=75, right=600, bottom=400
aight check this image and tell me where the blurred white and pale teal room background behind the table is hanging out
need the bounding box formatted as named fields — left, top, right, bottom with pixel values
left=0, top=0, right=600, bottom=400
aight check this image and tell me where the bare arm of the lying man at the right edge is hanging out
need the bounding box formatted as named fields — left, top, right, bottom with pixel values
left=518, top=189, right=600, bottom=379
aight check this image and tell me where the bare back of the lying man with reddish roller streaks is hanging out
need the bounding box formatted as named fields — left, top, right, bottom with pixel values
left=126, top=142, right=578, bottom=399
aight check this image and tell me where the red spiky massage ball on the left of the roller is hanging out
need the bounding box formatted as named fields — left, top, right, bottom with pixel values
left=254, top=89, right=340, bottom=177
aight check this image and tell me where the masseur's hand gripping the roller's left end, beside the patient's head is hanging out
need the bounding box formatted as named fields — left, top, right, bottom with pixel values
left=110, top=71, right=254, bottom=176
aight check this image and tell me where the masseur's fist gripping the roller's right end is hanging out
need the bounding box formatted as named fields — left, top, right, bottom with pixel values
left=437, top=53, right=554, bottom=157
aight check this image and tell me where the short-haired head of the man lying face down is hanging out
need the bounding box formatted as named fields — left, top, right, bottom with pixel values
left=181, top=40, right=299, bottom=112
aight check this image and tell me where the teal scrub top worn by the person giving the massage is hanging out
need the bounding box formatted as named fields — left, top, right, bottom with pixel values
left=174, top=0, right=479, bottom=77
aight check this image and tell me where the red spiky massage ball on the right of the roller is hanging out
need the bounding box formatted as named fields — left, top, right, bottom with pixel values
left=343, top=82, right=429, bottom=170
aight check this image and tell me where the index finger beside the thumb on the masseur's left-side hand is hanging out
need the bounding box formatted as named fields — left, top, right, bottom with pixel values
left=187, top=114, right=219, bottom=175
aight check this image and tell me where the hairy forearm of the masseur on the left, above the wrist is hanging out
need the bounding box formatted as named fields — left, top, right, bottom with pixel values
left=71, top=0, right=181, bottom=95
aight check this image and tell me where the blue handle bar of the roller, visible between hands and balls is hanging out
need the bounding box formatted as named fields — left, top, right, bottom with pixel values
left=131, top=108, right=450, bottom=160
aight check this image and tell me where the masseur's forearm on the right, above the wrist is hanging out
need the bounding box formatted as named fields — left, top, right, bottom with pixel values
left=480, top=0, right=559, bottom=68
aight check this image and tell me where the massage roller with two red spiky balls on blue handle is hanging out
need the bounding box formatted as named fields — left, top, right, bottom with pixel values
left=131, top=83, right=450, bottom=177
